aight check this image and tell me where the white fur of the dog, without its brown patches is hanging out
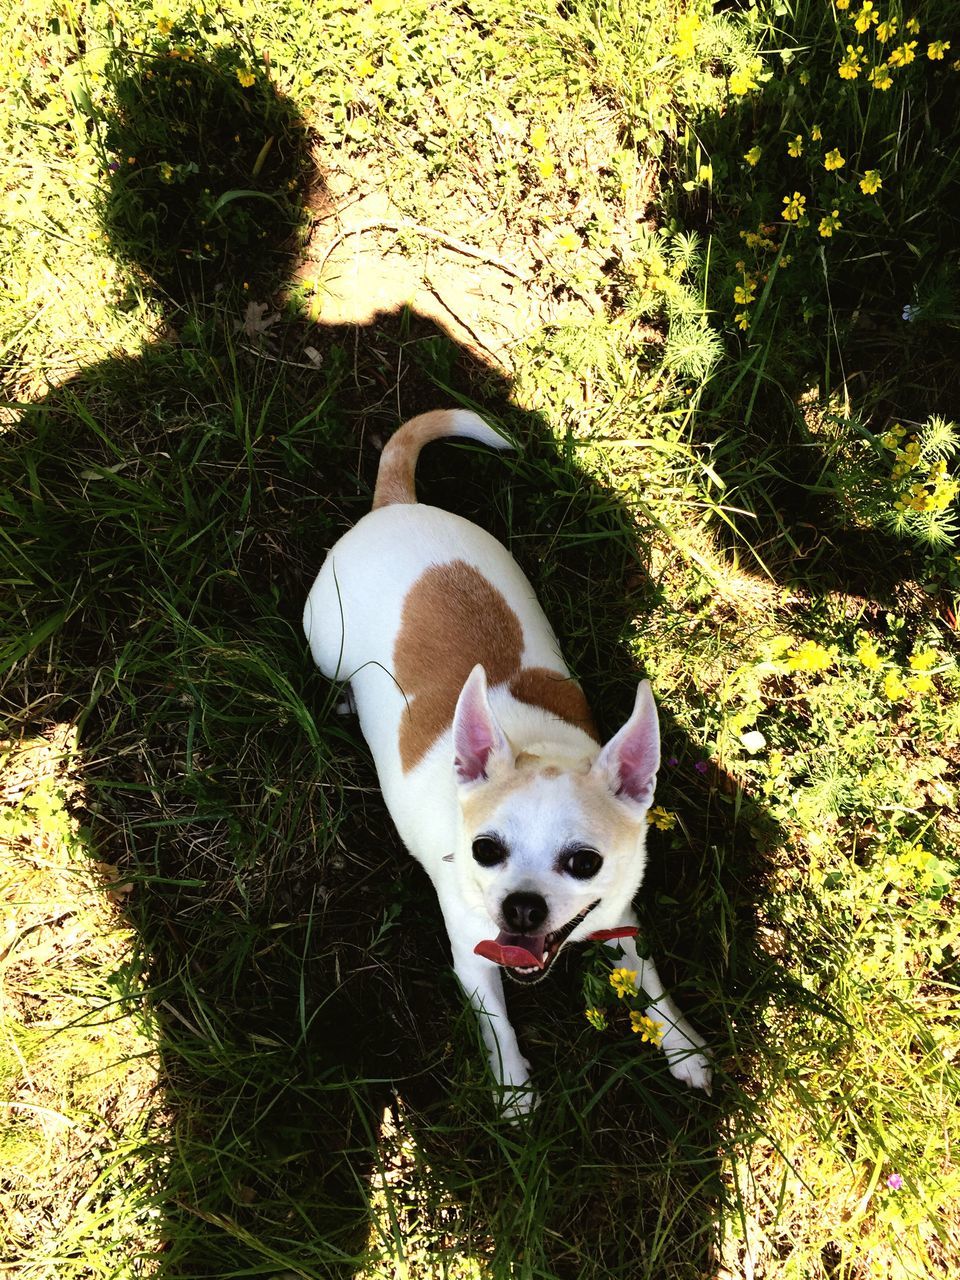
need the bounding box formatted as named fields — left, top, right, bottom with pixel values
left=303, top=411, right=710, bottom=1115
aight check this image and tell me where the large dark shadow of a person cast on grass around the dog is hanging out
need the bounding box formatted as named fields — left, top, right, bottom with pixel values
left=3, top=40, right=814, bottom=1280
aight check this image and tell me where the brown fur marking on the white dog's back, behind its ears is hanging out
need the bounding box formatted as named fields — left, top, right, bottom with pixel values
left=393, top=561, right=599, bottom=772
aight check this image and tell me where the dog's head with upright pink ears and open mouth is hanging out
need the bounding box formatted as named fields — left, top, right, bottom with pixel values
left=453, top=667, right=659, bottom=982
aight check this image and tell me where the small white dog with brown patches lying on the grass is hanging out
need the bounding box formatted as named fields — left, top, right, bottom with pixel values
left=303, top=410, right=710, bottom=1119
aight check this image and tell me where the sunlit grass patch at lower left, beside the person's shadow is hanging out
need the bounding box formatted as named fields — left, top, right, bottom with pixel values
left=0, top=730, right=163, bottom=1276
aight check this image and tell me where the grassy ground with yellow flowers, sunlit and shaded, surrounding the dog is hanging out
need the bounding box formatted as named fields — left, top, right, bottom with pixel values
left=0, top=0, right=960, bottom=1280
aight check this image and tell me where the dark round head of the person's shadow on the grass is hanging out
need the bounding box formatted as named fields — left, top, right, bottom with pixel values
left=100, top=31, right=325, bottom=302
